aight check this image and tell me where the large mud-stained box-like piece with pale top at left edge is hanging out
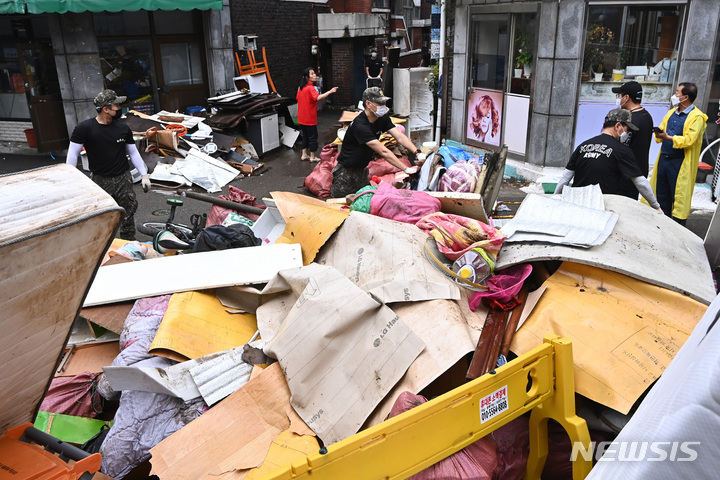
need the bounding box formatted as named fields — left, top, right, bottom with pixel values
left=0, top=164, right=123, bottom=436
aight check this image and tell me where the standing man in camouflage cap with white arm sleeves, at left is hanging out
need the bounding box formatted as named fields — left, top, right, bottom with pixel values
left=66, top=90, right=150, bottom=240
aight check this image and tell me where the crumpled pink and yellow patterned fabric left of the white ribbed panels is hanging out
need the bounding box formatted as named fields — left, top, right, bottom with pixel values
left=416, top=213, right=506, bottom=261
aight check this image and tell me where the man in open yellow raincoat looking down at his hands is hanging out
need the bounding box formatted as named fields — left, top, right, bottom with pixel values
left=650, top=82, right=707, bottom=225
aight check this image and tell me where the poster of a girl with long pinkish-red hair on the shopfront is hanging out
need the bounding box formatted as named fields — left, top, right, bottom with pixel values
left=467, top=89, right=503, bottom=146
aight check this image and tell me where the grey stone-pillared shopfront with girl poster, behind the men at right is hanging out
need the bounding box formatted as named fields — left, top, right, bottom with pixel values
left=444, top=0, right=720, bottom=171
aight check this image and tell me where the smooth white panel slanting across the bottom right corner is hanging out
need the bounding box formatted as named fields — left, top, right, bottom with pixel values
left=587, top=297, right=720, bottom=480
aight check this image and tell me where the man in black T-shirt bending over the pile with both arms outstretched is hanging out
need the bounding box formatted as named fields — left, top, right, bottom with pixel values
left=330, top=87, right=422, bottom=198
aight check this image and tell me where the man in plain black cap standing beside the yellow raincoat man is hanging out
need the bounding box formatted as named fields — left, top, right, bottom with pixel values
left=612, top=81, right=653, bottom=198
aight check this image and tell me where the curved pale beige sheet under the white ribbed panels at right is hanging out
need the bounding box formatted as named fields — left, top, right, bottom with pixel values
left=495, top=195, right=715, bottom=305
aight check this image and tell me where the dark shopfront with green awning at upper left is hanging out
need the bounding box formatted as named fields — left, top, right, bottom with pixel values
left=0, top=0, right=233, bottom=152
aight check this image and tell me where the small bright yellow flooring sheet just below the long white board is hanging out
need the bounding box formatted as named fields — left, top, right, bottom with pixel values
left=150, top=288, right=257, bottom=360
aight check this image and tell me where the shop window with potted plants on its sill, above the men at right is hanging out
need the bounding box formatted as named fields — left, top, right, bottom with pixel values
left=582, top=5, right=684, bottom=83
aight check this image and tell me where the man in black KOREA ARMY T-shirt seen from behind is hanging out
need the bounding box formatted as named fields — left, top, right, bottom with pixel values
left=555, top=108, right=662, bottom=212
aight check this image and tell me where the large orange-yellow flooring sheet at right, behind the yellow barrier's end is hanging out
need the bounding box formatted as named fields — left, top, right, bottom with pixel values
left=510, top=262, right=707, bottom=413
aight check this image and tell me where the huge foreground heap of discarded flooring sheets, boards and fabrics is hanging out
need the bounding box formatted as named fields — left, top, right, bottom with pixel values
left=0, top=165, right=715, bottom=479
